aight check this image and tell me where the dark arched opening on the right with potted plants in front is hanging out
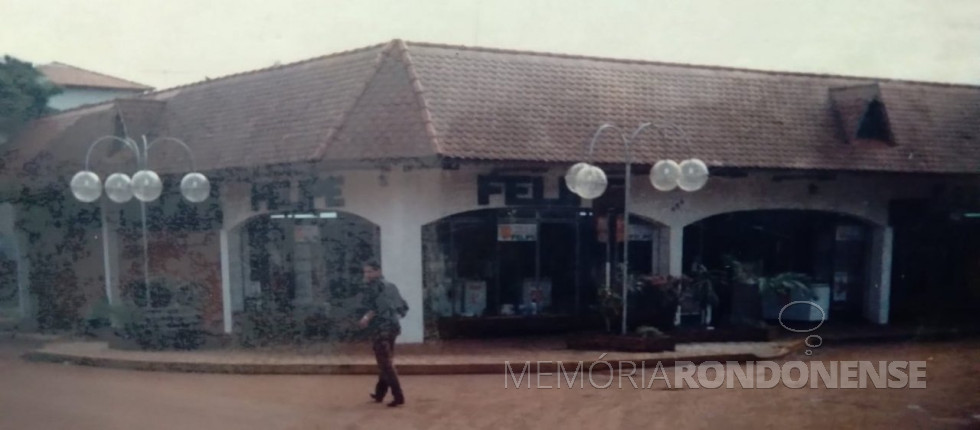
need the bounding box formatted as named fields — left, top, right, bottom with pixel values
left=684, top=210, right=874, bottom=321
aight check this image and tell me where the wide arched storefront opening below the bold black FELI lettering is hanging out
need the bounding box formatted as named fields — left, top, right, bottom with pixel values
left=422, top=207, right=662, bottom=337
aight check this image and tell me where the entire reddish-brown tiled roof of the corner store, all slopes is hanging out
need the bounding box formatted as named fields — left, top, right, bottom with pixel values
left=4, top=41, right=980, bottom=187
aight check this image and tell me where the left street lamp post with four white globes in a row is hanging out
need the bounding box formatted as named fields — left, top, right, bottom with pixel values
left=70, top=136, right=211, bottom=304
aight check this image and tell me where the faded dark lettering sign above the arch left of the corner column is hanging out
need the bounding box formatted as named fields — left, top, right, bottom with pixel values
left=252, top=176, right=344, bottom=211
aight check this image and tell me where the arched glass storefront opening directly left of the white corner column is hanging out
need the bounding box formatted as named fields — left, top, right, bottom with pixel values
left=232, top=211, right=381, bottom=336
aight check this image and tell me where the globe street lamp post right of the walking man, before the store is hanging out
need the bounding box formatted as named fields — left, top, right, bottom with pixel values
left=565, top=122, right=708, bottom=335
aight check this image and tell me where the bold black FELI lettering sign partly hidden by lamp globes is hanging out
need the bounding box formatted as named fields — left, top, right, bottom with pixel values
left=477, top=175, right=579, bottom=206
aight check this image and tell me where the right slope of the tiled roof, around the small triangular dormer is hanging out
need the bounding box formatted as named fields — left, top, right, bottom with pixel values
left=409, top=44, right=980, bottom=172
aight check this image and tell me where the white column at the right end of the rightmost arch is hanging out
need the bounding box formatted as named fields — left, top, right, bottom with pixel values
left=864, top=227, right=894, bottom=324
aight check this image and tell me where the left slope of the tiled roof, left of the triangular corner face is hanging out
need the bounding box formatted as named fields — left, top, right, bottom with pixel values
left=3, top=45, right=394, bottom=183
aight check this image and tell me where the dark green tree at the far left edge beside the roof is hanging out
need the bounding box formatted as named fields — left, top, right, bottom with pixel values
left=0, top=55, right=61, bottom=144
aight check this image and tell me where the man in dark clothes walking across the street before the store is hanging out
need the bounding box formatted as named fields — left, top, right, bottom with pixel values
left=359, top=261, right=408, bottom=407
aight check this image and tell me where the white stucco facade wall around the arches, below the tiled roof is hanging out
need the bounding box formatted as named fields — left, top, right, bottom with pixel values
left=222, top=166, right=976, bottom=342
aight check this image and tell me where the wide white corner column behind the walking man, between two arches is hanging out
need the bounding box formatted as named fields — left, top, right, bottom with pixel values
left=380, top=215, right=425, bottom=343
